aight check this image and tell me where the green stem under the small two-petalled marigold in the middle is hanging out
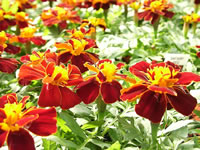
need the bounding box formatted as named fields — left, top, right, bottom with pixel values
left=96, top=96, right=106, bottom=121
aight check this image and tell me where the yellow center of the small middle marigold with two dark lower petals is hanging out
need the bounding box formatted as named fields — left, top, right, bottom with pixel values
left=99, top=62, right=117, bottom=82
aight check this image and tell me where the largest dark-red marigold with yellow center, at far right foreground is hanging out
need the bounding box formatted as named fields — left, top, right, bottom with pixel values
left=121, top=61, right=200, bottom=123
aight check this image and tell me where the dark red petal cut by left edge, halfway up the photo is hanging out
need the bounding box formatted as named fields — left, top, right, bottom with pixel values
left=0, top=58, right=19, bottom=73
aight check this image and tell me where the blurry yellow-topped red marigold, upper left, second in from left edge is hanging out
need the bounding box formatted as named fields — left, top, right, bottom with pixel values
left=17, top=27, right=46, bottom=45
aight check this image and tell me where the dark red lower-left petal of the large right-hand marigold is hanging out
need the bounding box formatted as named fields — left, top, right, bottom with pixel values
left=135, top=91, right=167, bottom=123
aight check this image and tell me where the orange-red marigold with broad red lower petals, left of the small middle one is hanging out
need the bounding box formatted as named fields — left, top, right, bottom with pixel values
left=19, top=53, right=82, bottom=109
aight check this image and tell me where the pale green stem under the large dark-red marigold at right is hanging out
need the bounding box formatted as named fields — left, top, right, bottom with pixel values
left=151, top=122, right=159, bottom=149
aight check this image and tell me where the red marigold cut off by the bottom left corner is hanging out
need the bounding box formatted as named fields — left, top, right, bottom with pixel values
left=0, top=93, right=57, bottom=150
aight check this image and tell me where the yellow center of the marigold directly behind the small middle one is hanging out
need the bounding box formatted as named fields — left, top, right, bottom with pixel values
left=70, top=39, right=88, bottom=56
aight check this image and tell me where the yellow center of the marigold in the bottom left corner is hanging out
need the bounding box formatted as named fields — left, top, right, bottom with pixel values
left=0, top=103, right=23, bottom=131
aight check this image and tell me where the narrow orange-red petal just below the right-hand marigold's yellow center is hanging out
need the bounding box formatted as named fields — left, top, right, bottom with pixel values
left=148, top=85, right=177, bottom=96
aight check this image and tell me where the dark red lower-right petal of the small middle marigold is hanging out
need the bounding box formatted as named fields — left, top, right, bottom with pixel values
left=101, top=81, right=122, bottom=104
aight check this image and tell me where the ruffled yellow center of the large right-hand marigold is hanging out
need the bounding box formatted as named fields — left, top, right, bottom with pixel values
left=147, top=66, right=178, bottom=87
